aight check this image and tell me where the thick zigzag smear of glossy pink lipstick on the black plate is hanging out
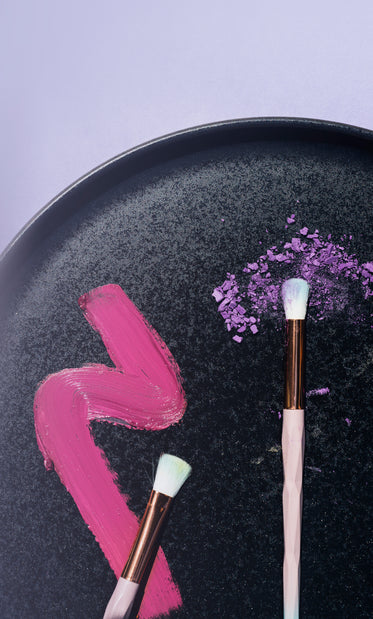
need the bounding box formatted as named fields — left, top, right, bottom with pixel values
left=34, top=284, right=186, bottom=619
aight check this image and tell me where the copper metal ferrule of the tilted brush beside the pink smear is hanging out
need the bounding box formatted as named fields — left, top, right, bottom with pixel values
left=122, top=490, right=172, bottom=583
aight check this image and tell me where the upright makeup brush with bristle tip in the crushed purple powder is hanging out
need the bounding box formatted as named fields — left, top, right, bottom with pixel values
left=282, top=279, right=309, bottom=619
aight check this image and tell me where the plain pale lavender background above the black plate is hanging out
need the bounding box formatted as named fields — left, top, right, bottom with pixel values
left=0, top=0, right=373, bottom=252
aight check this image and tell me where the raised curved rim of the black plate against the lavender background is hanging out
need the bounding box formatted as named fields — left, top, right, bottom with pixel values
left=0, top=116, right=373, bottom=281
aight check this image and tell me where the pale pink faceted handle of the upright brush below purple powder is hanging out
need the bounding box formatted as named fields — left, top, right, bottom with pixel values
left=282, top=409, right=304, bottom=619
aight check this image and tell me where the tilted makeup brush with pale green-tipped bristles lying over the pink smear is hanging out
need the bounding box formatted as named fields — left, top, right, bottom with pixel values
left=104, top=454, right=192, bottom=619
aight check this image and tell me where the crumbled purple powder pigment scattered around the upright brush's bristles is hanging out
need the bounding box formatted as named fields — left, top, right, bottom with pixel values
left=213, top=218, right=373, bottom=342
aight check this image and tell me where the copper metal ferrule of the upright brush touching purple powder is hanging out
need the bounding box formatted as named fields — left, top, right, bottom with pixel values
left=284, top=320, right=305, bottom=410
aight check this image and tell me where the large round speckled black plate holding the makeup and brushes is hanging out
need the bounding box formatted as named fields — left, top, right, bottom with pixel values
left=0, top=120, right=373, bottom=619
